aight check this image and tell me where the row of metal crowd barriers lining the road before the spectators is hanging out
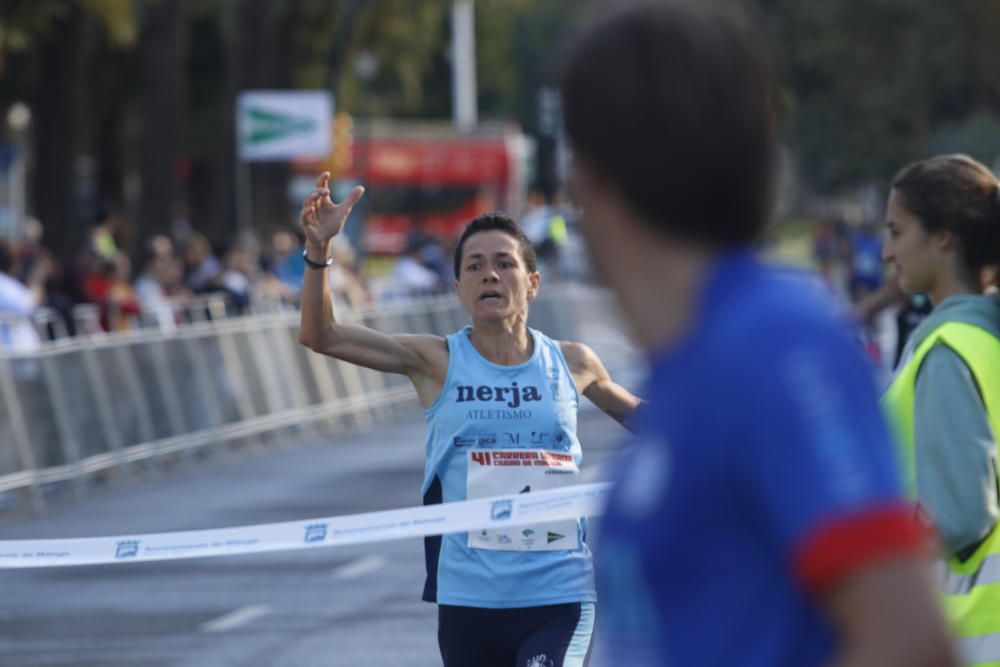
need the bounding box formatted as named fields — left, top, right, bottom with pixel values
left=0, top=285, right=628, bottom=505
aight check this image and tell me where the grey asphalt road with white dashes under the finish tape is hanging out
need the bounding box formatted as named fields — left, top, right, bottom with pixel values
left=0, top=409, right=623, bottom=667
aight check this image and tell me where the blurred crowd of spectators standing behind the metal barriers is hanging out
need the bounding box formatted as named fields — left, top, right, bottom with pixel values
left=0, top=183, right=585, bottom=340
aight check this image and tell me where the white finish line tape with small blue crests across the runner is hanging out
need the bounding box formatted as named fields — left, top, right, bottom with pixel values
left=0, top=483, right=610, bottom=569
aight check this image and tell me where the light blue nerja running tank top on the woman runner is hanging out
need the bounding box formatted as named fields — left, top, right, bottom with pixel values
left=422, top=327, right=596, bottom=608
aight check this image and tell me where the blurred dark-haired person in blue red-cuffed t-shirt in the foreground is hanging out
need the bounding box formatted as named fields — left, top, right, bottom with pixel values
left=562, top=2, right=954, bottom=667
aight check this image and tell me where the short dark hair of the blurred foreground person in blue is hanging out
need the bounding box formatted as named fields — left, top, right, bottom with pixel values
left=561, top=1, right=776, bottom=246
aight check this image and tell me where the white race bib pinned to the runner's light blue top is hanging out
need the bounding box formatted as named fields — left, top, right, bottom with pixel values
left=466, top=449, right=580, bottom=551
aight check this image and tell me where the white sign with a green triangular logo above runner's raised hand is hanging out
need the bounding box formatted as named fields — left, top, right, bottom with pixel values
left=236, top=90, right=333, bottom=162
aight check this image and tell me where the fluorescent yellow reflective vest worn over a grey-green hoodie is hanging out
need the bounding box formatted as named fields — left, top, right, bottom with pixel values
left=882, top=322, right=1000, bottom=667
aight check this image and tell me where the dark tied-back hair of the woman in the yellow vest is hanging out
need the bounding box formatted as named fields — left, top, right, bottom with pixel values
left=892, top=155, right=1000, bottom=284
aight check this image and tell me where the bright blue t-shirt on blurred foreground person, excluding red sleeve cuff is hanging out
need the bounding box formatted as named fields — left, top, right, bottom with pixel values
left=596, top=252, right=899, bottom=667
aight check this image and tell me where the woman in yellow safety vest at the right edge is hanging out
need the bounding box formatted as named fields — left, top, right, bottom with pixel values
left=882, top=155, right=1000, bottom=667
